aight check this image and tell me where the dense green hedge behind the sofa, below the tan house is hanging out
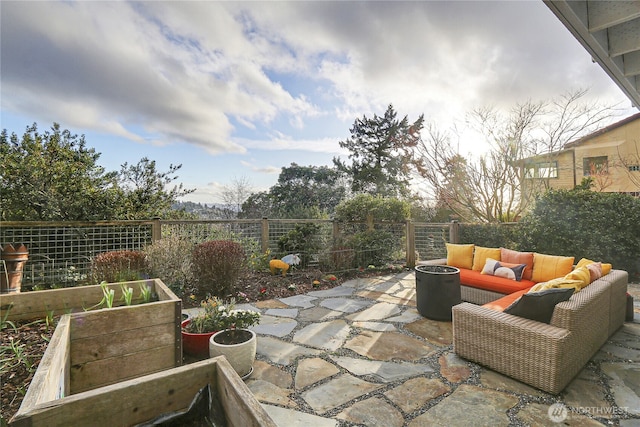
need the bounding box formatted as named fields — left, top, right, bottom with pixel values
left=460, top=190, right=640, bottom=282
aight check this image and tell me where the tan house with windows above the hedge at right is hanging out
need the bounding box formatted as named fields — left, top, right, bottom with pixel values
left=521, top=113, right=640, bottom=197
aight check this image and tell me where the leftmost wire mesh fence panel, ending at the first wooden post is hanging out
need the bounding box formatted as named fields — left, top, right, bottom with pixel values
left=0, top=221, right=152, bottom=289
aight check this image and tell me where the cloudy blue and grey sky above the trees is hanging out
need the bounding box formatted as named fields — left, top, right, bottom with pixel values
left=0, top=0, right=637, bottom=203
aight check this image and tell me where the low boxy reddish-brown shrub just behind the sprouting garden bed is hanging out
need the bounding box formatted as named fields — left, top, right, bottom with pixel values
left=91, top=251, right=147, bottom=283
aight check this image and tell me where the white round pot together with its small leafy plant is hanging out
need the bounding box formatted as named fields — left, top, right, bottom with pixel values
left=209, top=305, right=260, bottom=379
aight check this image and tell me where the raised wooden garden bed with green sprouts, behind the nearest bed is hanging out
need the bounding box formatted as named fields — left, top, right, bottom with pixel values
left=0, top=279, right=182, bottom=413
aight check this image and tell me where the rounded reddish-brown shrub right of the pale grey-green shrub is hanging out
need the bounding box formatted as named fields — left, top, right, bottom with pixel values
left=192, top=240, right=246, bottom=298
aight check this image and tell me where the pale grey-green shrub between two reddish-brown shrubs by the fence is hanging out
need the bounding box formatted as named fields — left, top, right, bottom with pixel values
left=144, top=236, right=194, bottom=296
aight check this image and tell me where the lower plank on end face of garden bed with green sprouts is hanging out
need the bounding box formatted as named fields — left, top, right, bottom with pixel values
left=70, top=345, right=175, bottom=394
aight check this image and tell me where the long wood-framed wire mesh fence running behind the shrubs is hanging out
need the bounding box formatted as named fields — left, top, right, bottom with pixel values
left=0, top=218, right=458, bottom=288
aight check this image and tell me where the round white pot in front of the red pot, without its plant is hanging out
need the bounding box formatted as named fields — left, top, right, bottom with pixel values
left=209, top=329, right=258, bottom=379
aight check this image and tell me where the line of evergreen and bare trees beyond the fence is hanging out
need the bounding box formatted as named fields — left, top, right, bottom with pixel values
left=0, top=91, right=632, bottom=223
